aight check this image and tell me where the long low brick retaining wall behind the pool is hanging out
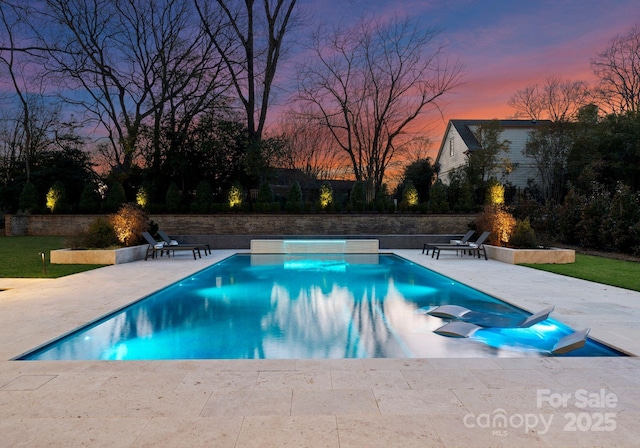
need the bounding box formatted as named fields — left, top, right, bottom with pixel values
left=5, top=214, right=475, bottom=249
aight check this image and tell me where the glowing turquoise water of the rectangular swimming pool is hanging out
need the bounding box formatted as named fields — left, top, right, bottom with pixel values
left=19, top=254, right=620, bottom=360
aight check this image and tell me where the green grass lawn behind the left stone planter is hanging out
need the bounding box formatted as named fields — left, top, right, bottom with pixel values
left=0, top=236, right=103, bottom=278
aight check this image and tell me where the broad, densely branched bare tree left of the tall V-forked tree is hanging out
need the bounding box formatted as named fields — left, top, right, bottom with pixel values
left=45, top=0, right=226, bottom=178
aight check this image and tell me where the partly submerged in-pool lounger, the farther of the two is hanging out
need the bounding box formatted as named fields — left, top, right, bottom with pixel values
left=427, top=305, right=555, bottom=328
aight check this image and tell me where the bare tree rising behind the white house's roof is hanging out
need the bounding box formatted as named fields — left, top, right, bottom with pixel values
left=508, top=76, right=592, bottom=122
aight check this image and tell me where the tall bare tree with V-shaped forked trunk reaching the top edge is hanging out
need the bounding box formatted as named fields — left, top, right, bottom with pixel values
left=194, top=0, right=296, bottom=142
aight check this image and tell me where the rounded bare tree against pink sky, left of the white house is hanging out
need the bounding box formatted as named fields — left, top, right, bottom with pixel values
left=298, top=13, right=462, bottom=191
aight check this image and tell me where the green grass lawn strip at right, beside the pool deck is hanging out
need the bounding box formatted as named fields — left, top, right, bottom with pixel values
left=523, top=254, right=640, bottom=291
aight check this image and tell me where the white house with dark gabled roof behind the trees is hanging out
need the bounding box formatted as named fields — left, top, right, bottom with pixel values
left=436, top=120, right=551, bottom=187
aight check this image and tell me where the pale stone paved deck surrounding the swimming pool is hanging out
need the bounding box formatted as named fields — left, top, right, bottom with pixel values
left=0, top=249, right=640, bottom=448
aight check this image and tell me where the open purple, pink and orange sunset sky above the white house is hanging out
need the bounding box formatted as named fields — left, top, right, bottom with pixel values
left=302, top=0, right=640, bottom=149
